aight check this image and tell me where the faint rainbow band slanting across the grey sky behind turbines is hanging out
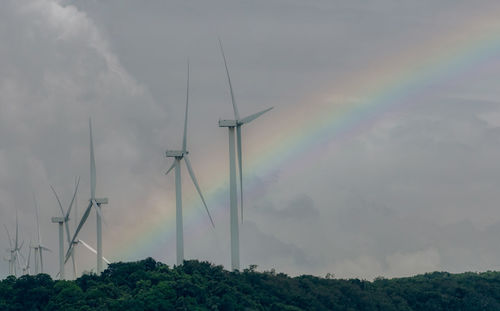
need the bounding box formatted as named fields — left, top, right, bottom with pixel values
left=110, top=7, right=500, bottom=260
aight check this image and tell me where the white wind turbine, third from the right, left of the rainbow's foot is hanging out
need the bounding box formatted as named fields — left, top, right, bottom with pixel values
left=66, top=118, right=108, bottom=274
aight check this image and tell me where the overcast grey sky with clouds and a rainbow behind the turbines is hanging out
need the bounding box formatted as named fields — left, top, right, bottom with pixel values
left=0, top=0, right=500, bottom=279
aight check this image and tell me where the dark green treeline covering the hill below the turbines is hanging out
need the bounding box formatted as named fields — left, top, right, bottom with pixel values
left=0, top=258, right=500, bottom=311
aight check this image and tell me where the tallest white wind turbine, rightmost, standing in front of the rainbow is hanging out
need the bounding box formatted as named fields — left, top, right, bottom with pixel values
left=219, top=39, right=273, bottom=270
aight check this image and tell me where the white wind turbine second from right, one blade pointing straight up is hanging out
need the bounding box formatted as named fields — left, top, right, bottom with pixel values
left=165, top=63, right=215, bottom=265
